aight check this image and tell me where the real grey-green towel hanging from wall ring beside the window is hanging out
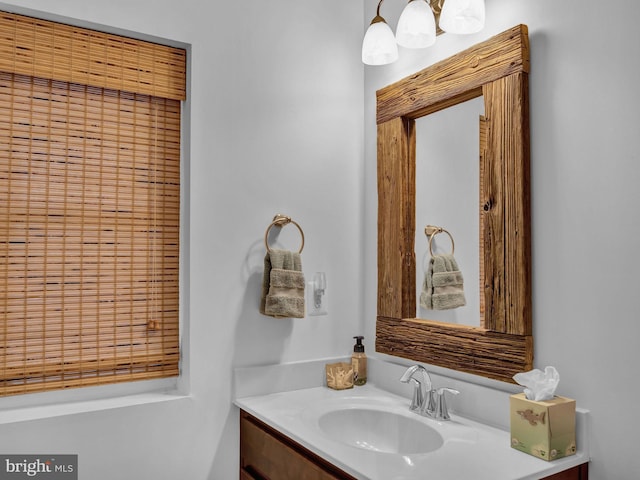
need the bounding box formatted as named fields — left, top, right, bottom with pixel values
left=260, top=249, right=305, bottom=318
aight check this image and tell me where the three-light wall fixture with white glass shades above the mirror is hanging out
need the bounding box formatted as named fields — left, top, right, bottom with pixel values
left=362, top=0, right=485, bottom=65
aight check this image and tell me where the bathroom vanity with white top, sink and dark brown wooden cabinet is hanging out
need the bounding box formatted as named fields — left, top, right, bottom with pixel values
left=235, top=385, right=588, bottom=480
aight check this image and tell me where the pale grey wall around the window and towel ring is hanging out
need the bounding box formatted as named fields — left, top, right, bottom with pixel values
left=0, top=0, right=363, bottom=480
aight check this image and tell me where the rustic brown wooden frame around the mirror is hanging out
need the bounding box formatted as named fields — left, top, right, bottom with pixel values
left=376, top=25, right=533, bottom=383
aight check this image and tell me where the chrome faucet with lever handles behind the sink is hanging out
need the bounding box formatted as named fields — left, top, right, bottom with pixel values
left=400, top=365, right=460, bottom=420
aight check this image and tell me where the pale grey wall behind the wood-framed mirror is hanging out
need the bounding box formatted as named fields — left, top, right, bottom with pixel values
left=363, top=0, right=640, bottom=480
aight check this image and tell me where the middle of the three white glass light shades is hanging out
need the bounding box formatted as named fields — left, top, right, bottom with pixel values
left=396, top=0, right=438, bottom=48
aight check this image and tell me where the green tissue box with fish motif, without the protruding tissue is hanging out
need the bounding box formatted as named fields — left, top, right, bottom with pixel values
left=510, top=393, right=576, bottom=461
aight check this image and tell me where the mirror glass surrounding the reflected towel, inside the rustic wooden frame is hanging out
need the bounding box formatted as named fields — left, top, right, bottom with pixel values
left=415, top=97, right=484, bottom=327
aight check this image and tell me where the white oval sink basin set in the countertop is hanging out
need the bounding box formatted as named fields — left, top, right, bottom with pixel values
left=318, top=408, right=444, bottom=455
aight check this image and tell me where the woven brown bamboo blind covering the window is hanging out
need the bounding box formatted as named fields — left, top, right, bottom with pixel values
left=0, top=12, right=186, bottom=395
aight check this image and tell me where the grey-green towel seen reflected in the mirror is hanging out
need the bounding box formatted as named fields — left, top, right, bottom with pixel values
left=420, top=254, right=467, bottom=310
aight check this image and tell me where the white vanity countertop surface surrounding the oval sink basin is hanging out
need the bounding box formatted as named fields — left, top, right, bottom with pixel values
left=234, top=383, right=589, bottom=480
